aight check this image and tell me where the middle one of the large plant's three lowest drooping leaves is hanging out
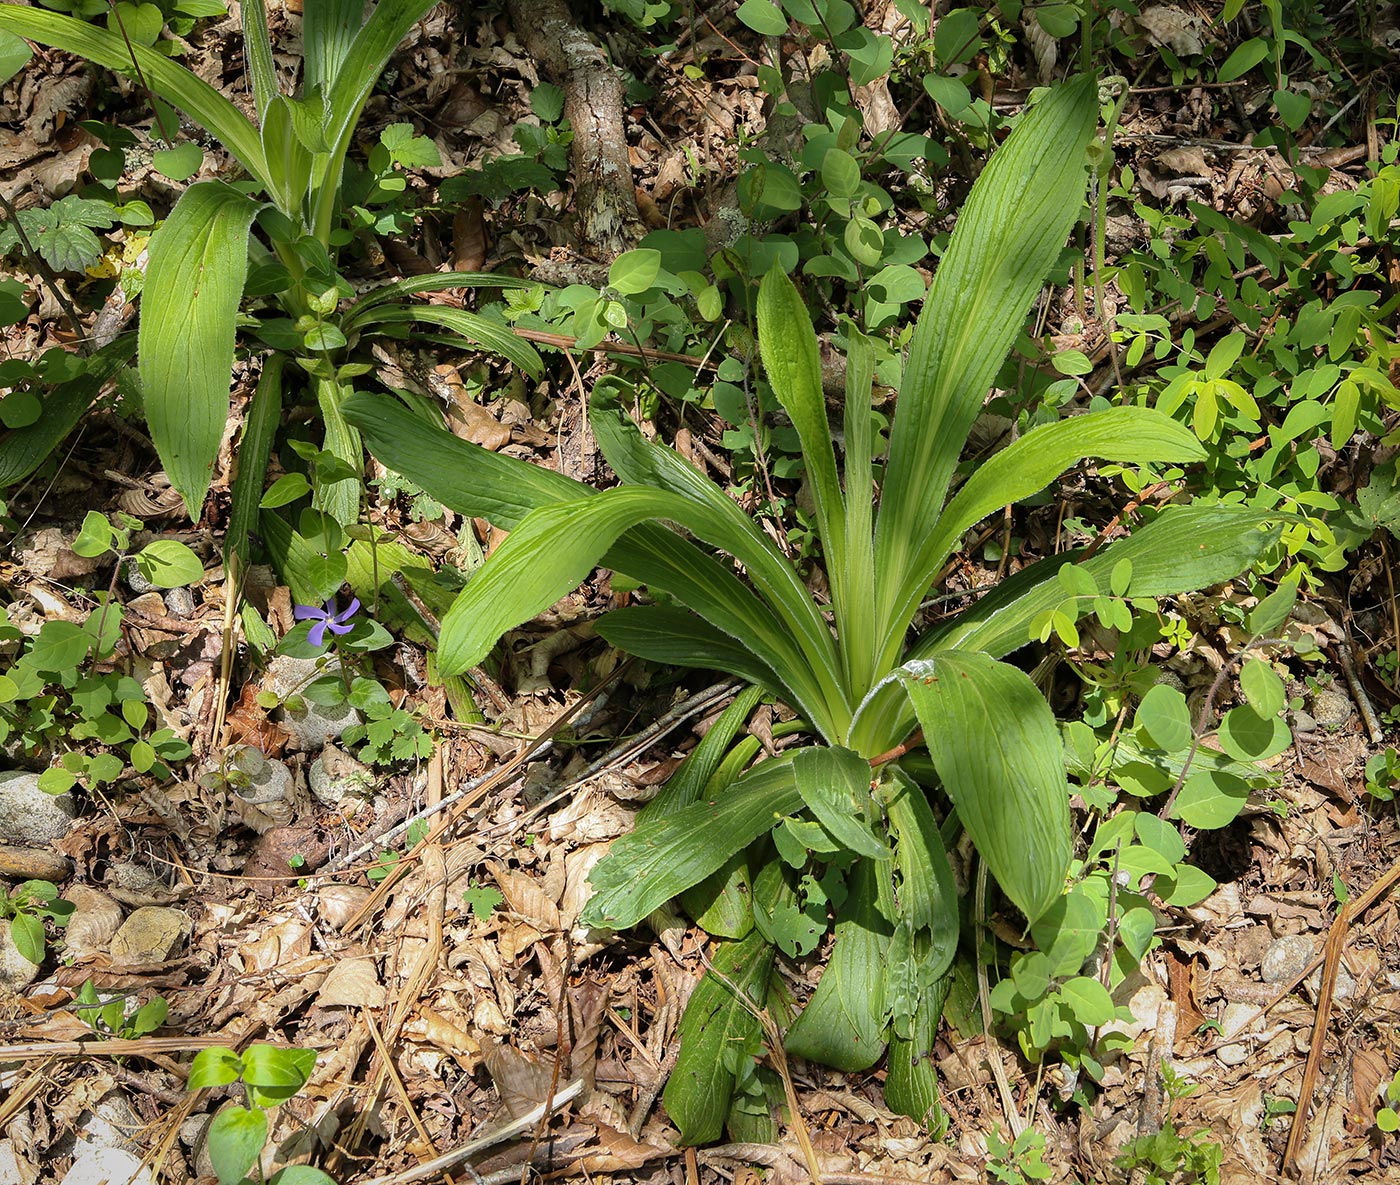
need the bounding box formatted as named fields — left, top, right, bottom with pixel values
left=784, top=857, right=893, bottom=1072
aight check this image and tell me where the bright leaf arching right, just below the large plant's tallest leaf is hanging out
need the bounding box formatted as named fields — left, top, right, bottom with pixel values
left=885, top=408, right=1205, bottom=670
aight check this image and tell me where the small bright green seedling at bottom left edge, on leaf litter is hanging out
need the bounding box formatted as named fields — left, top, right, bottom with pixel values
left=185, top=1045, right=336, bottom=1185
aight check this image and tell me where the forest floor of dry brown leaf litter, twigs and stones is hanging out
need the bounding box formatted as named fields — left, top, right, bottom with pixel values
left=0, top=2, right=1400, bottom=1185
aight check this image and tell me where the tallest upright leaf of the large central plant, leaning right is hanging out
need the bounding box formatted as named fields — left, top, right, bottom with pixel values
left=875, top=77, right=1098, bottom=649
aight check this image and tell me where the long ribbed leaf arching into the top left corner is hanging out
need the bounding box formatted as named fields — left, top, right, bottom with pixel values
left=0, top=4, right=270, bottom=188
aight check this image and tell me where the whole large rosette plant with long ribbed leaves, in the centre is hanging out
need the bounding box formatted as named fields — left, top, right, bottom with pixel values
left=338, top=80, right=1273, bottom=1142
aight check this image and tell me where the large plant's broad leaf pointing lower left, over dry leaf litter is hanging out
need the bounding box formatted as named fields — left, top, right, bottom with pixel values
left=581, top=756, right=802, bottom=930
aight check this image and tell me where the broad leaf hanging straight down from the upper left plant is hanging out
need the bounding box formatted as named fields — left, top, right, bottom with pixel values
left=139, top=181, right=258, bottom=520
